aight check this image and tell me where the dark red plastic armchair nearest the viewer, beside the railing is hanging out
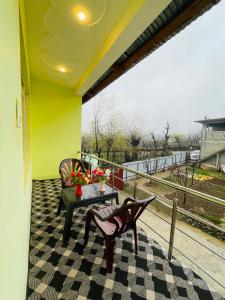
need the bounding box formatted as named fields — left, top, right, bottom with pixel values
left=84, top=196, right=156, bottom=273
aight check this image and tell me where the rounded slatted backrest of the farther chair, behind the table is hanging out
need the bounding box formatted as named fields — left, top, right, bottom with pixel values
left=59, top=158, right=85, bottom=188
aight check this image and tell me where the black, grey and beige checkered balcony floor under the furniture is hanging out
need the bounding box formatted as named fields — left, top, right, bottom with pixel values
left=27, top=180, right=222, bottom=300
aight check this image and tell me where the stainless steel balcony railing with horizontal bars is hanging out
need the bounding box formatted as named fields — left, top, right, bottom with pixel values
left=78, top=152, right=225, bottom=291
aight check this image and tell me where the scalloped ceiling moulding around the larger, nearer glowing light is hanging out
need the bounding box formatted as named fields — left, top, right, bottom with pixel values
left=44, top=0, right=107, bottom=47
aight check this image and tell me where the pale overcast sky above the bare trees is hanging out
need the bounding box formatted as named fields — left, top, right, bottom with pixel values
left=82, top=1, right=225, bottom=134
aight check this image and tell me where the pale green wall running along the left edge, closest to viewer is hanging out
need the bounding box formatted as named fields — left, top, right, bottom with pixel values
left=0, top=0, right=31, bottom=300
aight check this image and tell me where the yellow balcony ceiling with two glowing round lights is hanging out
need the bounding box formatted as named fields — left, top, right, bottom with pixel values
left=26, top=0, right=170, bottom=95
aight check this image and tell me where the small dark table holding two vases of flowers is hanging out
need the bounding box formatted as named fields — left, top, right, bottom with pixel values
left=57, top=183, right=119, bottom=245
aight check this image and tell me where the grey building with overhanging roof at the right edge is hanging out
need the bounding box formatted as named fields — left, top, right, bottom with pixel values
left=195, top=118, right=225, bottom=170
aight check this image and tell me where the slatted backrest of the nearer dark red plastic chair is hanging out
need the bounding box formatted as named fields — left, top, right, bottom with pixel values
left=113, top=196, right=156, bottom=234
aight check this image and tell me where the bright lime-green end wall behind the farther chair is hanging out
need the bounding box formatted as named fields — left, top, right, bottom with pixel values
left=31, top=78, right=82, bottom=179
